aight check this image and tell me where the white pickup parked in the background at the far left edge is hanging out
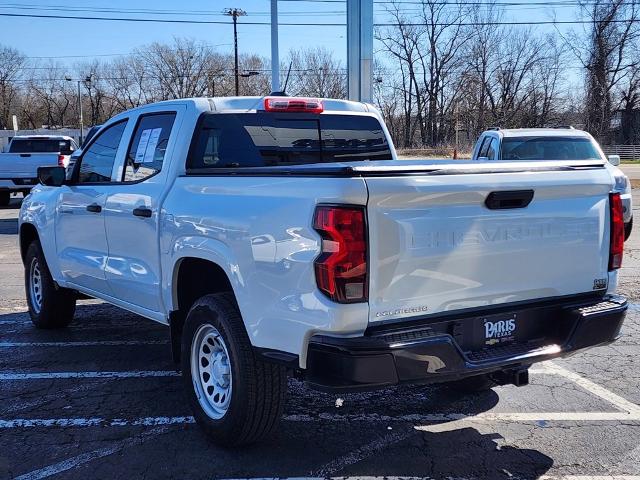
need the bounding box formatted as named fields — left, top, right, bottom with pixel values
left=0, top=135, right=78, bottom=206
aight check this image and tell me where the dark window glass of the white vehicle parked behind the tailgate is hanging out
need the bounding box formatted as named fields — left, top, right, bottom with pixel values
left=502, top=137, right=602, bottom=160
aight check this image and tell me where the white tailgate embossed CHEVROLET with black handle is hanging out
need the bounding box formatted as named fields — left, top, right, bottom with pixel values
left=366, top=165, right=612, bottom=323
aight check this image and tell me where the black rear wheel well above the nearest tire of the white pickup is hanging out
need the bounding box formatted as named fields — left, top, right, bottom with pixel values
left=169, top=258, right=233, bottom=363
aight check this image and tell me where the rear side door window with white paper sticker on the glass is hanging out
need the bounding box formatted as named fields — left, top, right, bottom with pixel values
left=123, top=113, right=176, bottom=182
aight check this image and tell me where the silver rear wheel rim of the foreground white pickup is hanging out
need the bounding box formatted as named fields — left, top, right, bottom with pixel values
left=191, top=324, right=232, bottom=420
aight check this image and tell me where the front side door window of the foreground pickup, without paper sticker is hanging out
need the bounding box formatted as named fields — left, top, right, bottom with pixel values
left=78, top=120, right=127, bottom=183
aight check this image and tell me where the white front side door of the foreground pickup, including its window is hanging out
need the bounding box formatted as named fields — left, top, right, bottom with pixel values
left=56, top=120, right=127, bottom=295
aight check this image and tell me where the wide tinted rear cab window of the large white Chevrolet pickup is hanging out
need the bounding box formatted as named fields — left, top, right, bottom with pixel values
left=188, top=112, right=392, bottom=168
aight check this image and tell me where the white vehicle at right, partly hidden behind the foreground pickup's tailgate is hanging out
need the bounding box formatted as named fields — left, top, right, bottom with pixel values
left=472, top=127, right=633, bottom=241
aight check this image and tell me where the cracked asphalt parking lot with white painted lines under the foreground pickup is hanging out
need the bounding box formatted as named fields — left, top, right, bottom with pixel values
left=0, top=190, right=640, bottom=480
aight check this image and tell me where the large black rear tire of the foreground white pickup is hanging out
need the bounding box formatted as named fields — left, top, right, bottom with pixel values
left=181, top=293, right=287, bottom=447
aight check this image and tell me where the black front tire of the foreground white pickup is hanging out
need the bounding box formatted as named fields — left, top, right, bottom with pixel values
left=24, top=240, right=76, bottom=329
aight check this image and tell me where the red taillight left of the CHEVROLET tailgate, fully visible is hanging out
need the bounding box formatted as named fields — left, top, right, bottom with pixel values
left=313, top=205, right=368, bottom=303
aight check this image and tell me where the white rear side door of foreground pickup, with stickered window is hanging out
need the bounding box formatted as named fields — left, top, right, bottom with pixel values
left=105, top=106, right=182, bottom=313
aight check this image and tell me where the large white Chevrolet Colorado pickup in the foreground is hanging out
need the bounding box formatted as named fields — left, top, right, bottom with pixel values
left=19, top=97, right=627, bottom=445
